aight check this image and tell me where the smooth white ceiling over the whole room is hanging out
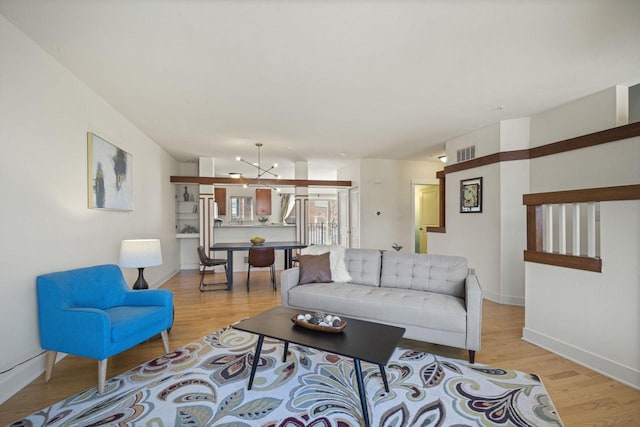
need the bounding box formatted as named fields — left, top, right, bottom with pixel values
left=0, top=0, right=640, bottom=179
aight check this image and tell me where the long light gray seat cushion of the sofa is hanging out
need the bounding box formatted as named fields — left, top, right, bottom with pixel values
left=288, top=283, right=467, bottom=334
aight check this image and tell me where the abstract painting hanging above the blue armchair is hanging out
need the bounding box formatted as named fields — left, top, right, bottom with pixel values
left=87, top=132, right=133, bottom=211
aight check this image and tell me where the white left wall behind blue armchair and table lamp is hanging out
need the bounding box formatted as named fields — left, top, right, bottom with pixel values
left=0, top=15, right=178, bottom=402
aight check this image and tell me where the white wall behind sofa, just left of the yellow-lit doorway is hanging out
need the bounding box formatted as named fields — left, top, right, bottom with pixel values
left=356, top=159, right=442, bottom=250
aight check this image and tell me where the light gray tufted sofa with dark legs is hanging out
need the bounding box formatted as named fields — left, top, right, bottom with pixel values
left=280, top=249, right=482, bottom=363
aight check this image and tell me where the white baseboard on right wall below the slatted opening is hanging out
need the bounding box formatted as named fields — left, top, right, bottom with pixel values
left=522, top=328, right=640, bottom=390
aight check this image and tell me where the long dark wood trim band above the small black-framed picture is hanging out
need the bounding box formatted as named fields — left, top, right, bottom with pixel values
left=436, top=122, right=640, bottom=177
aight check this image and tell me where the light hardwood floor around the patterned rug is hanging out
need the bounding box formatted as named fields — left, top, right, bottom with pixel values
left=0, top=270, right=640, bottom=427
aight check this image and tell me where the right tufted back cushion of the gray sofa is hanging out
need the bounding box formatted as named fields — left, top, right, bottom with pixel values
left=380, top=251, right=467, bottom=298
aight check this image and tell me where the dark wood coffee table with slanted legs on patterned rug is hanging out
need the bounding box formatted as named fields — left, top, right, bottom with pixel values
left=233, top=307, right=404, bottom=426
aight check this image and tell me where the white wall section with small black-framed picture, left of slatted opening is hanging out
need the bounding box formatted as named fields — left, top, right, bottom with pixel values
left=428, top=118, right=530, bottom=305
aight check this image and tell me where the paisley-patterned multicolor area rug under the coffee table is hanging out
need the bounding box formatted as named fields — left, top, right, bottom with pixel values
left=13, top=328, right=562, bottom=427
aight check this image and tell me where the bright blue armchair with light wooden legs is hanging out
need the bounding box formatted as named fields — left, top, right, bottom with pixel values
left=36, top=264, right=173, bottom=393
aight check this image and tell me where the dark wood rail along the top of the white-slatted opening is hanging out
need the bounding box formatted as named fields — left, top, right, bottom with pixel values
left=522, top=184, right=640, bottom=206
